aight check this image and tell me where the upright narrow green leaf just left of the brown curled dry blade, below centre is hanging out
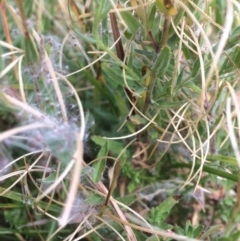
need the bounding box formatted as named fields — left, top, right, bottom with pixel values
left=92, top=141, right=109, bottom=183
